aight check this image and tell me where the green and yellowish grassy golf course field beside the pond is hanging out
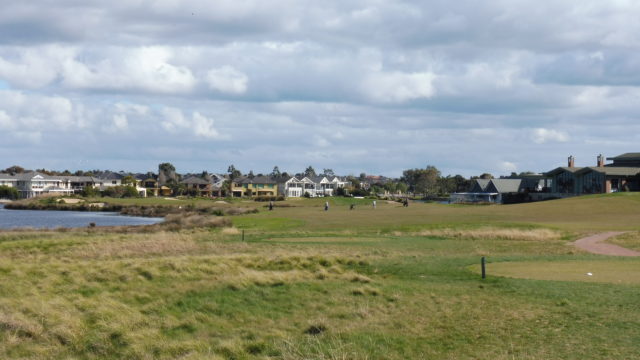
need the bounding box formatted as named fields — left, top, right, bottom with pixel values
left=0, top=194, right=640, bottom=359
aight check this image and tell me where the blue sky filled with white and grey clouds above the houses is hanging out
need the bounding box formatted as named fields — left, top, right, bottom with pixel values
left=0, top=0, right=640, bottom=177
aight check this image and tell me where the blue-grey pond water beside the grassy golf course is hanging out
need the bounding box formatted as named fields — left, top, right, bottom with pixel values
left=0, top=204, right=163, bottom=229
